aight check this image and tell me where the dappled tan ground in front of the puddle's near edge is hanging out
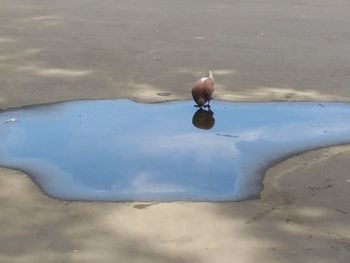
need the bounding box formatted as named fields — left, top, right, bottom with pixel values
left=0, top=146, right=350, bottom=263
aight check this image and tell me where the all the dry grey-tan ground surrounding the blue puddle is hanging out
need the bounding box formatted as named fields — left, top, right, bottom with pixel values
left=0, top=0, right=350, bottom=263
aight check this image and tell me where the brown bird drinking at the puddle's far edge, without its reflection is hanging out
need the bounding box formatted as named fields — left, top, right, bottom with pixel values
left=192, top=70, right=215, bottom=108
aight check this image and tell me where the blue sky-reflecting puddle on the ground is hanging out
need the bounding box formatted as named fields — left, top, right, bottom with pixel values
left=0, top=100, right=350, bottom=201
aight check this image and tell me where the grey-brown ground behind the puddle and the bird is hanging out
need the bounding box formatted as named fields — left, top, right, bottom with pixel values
left=0, top=0, right=350, bottom=109
